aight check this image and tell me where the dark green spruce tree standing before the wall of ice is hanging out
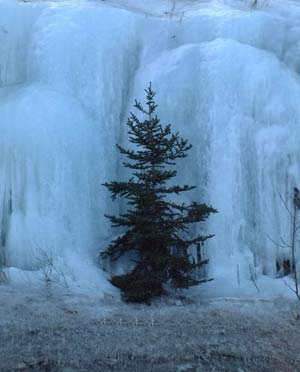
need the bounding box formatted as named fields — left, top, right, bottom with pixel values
left=101, top=83, right=216, bottom=302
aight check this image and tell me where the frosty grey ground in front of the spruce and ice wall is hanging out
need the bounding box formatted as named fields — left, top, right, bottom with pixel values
left=0, top=286, right=300, bottom=372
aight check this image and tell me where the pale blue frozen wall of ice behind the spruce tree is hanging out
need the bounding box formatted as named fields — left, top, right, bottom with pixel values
left=0, top=0, right=300, bottom=290
